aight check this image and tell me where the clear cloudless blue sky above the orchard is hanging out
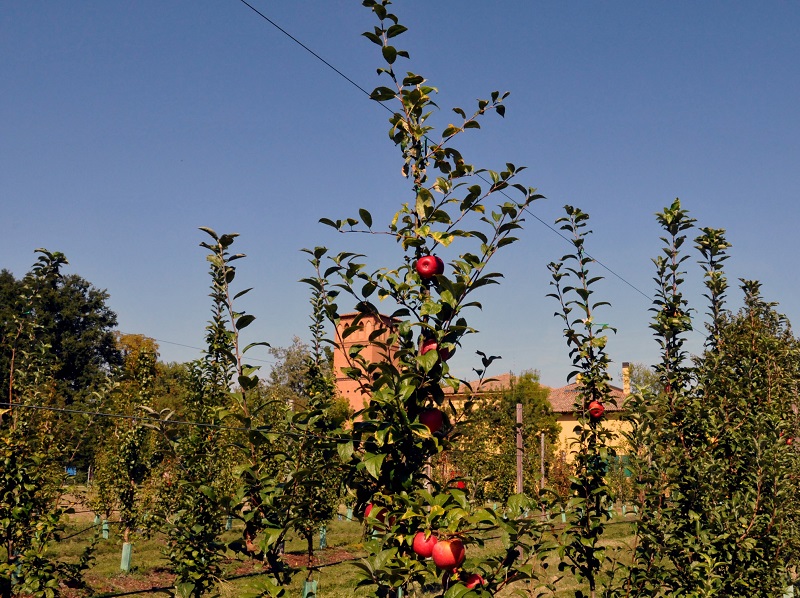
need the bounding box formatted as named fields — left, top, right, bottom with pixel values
left=0, top=0, right=800, bottom=385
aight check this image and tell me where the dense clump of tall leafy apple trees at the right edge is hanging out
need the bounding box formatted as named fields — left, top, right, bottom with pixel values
left=622, top=200, right=800, bottom=596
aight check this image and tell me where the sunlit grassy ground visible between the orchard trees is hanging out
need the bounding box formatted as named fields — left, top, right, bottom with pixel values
left=47, top=510, right=631, bottom=598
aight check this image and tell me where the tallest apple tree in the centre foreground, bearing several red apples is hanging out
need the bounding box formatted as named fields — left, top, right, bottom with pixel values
left=312, top=0, right=552, bottom=596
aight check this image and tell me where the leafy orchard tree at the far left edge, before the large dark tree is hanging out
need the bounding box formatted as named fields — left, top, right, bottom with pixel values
left=0, top=250, right=93, bottom=598
